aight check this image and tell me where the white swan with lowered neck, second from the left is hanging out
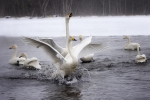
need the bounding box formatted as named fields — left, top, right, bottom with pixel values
left=19, top=53, right=41, bottom=69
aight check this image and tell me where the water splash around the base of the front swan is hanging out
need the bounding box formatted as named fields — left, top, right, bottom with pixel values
left=37, top=64, right=91, bottom=84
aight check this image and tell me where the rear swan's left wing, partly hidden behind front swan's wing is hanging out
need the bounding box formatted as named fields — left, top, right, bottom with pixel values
left=39, top=38, right=63, bottom=53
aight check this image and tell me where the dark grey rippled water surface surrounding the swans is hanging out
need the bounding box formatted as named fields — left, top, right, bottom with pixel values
left=0, top=36, right=150, bottom=100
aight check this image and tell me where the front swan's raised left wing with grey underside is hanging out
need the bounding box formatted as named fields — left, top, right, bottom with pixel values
left=22, top=37, right=65, bottom=63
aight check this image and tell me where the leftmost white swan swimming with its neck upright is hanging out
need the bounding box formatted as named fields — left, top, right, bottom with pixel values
left=8, top=45, right=25, bottom=65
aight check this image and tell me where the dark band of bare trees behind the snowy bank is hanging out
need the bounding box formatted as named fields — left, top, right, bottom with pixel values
left=0, top=0, right=150, bottom=17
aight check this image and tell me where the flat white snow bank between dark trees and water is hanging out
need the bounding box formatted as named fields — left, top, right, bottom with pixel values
left=0, top=16, right=150, bottom=37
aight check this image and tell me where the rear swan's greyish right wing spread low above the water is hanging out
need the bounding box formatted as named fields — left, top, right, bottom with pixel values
left=78, top=44, right=109, bottom=58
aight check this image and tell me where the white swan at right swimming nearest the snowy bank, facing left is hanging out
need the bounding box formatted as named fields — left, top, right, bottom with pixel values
left=123, top=36, right=140, bottom=50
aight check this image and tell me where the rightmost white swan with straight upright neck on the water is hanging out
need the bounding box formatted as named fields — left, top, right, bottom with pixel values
left=135, top=45, right=147, bottom=63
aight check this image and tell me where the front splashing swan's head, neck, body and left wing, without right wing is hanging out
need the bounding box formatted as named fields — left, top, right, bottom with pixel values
left=22, top=36, right=78, bottom=79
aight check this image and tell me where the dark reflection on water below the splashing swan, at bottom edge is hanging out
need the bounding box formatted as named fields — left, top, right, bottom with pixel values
left=43, top=85, right=82, bottom=100
